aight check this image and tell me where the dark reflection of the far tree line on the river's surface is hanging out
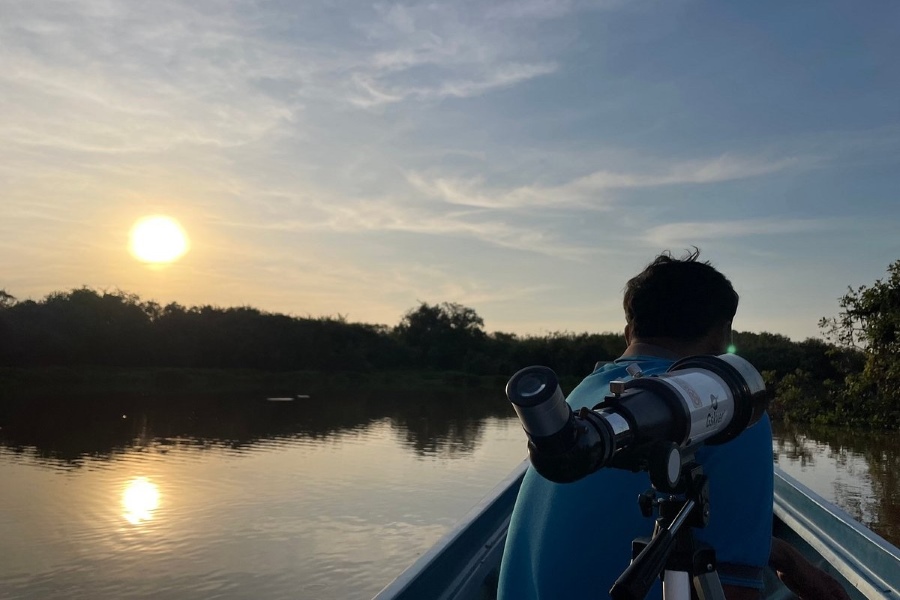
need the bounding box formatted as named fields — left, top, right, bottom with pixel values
left=0, top=389, right=512, bottom=470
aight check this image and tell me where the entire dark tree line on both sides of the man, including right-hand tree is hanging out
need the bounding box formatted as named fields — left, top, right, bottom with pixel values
left=0, top=261, right=900, bottom=427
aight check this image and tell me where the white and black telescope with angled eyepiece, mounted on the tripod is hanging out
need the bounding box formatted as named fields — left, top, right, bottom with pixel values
left=506, top=354, right=768, bottom=491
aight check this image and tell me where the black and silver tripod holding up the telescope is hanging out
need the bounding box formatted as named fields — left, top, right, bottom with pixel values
left=609, top=458, right=725, bottom=600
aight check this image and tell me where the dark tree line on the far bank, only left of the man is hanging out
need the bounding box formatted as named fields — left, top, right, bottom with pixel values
left=0, top=287, right=624, bottom=375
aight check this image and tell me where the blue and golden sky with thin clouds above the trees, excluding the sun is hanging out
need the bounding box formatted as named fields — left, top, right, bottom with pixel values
left=0, top=0, right=900, bottom=341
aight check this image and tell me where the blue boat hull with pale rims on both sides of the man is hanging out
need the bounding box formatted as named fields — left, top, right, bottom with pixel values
left=375, top=461, right=900, bottom=600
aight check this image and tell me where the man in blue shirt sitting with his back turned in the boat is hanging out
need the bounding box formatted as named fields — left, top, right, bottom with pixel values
left=499, top=250, right=773, bottom=600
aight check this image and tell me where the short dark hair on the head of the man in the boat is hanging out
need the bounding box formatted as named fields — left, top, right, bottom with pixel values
left=623, top=248, right=738, bottom=340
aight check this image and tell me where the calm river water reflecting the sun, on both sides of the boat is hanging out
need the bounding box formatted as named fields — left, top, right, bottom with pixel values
left=0, top=391, right=900, bottom=600
